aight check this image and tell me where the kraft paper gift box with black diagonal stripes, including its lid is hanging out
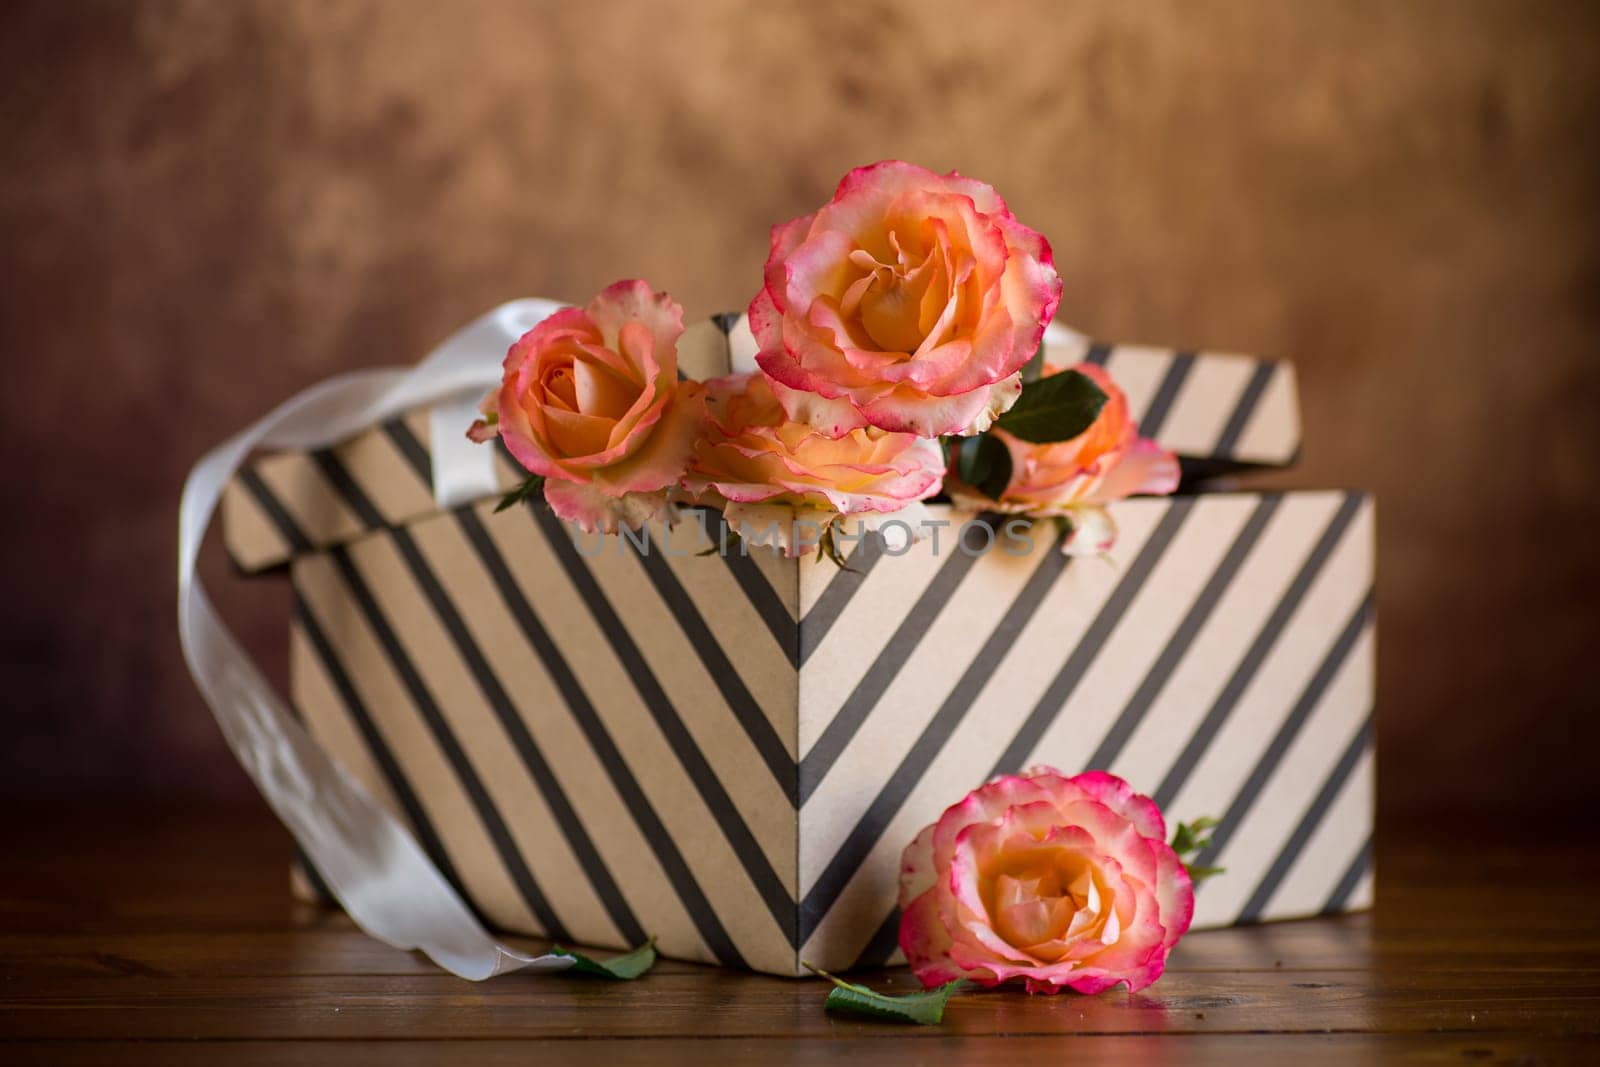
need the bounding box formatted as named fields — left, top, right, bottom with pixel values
left=224, top=317, right=1374, bottom=974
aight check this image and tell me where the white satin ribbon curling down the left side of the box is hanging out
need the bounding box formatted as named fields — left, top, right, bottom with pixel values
left=178, top=299, right=573, bottom=981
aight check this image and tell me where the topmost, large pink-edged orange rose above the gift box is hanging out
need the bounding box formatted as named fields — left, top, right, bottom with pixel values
left=750, top=162, right=1061, bottom=437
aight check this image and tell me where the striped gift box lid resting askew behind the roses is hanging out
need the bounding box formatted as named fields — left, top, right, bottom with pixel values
left=222, top=314, right=1301, bottom=573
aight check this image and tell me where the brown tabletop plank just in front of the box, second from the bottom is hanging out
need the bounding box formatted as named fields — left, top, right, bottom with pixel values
left=0, top=969, right=1600, bottom=1040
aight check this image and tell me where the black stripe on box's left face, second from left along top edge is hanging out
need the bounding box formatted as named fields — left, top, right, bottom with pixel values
left=390, top=530, right=648, bottom=945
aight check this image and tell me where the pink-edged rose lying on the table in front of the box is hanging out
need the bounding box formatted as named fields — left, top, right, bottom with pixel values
left=899, top=768, right=1194, bottom=993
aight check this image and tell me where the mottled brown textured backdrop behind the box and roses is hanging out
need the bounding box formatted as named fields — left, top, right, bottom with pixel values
left=0, top=0, right=1600, bottom=813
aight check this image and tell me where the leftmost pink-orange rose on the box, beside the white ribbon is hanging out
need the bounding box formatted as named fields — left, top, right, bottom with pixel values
left=470, top=282, right=704, bottom=533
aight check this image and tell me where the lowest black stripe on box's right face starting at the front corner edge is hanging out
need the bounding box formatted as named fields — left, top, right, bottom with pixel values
left=800, top=537, right=1069, bottom=944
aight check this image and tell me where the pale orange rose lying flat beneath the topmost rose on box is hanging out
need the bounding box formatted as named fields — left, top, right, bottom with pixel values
left=683, top=374, right=944, bottom=555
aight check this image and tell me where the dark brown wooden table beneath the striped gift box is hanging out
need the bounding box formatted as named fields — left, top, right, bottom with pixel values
left=0, top=803, right=1600, bottom=1067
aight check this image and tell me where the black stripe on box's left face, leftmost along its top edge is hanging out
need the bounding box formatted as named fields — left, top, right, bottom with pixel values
left=328, top=545, right=570, bottom=941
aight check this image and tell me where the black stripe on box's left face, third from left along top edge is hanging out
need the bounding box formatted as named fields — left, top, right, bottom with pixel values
left=454, top=507, right=747, bottom=968
